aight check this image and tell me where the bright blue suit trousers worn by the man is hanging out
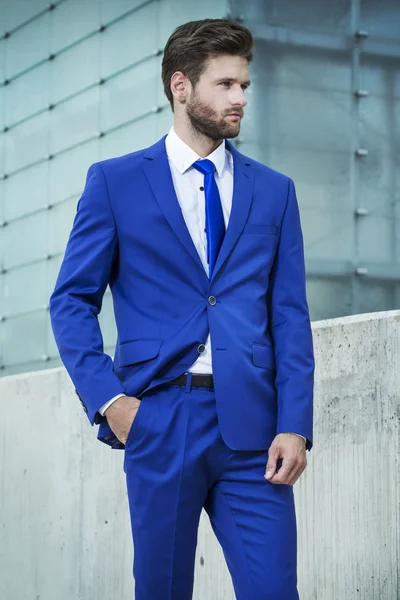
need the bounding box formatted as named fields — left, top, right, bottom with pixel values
left=124, top=372, right=299, bottom=600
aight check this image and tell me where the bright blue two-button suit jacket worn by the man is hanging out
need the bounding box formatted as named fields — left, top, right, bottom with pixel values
left=50, top=135, right=314, bottom=450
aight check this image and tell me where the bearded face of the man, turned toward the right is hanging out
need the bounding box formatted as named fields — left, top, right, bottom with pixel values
left=185, top=55, right=250, bottom=141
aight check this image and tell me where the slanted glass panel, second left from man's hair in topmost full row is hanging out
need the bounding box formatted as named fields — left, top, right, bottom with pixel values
left=50, top=35, right=100, bottom=102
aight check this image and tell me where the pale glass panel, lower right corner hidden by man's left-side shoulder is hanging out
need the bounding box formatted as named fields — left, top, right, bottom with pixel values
left=48, top=139, right=99, bottom=204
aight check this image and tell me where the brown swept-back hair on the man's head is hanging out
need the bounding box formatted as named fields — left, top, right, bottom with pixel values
left=161, top=19, right=254, bottom=112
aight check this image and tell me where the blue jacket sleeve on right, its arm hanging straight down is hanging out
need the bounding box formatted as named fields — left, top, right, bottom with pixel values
left=267, top=178, right=315, bottom=450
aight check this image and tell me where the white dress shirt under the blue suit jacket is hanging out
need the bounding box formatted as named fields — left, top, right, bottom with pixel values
left=99, top=126, right=306, bottom=441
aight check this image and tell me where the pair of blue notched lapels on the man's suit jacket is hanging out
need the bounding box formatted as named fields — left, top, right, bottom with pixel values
left=143, top=135, right=254, bottom=281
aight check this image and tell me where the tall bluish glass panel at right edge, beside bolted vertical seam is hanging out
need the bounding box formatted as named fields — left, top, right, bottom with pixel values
left=357, top=55, right=400, bottom=264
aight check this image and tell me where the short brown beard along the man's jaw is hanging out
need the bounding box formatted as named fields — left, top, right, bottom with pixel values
left=186, top=89, right=240, bottom=141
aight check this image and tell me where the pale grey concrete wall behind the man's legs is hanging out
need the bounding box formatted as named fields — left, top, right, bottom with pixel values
left=0, top=310, right=400, bottom=600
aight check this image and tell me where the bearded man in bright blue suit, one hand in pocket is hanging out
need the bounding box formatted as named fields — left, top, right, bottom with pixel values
left=50, top=19, right=314, bottom=600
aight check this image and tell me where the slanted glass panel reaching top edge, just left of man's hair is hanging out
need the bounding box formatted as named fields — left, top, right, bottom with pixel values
left=101, top=2, right=159, bottom=77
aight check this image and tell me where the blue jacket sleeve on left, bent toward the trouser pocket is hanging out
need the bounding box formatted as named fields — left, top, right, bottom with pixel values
left=49, top=163, right=124, bottom=425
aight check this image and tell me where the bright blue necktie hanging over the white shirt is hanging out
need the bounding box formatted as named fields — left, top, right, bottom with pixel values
left=193, top=158, right=225, bottom=279
